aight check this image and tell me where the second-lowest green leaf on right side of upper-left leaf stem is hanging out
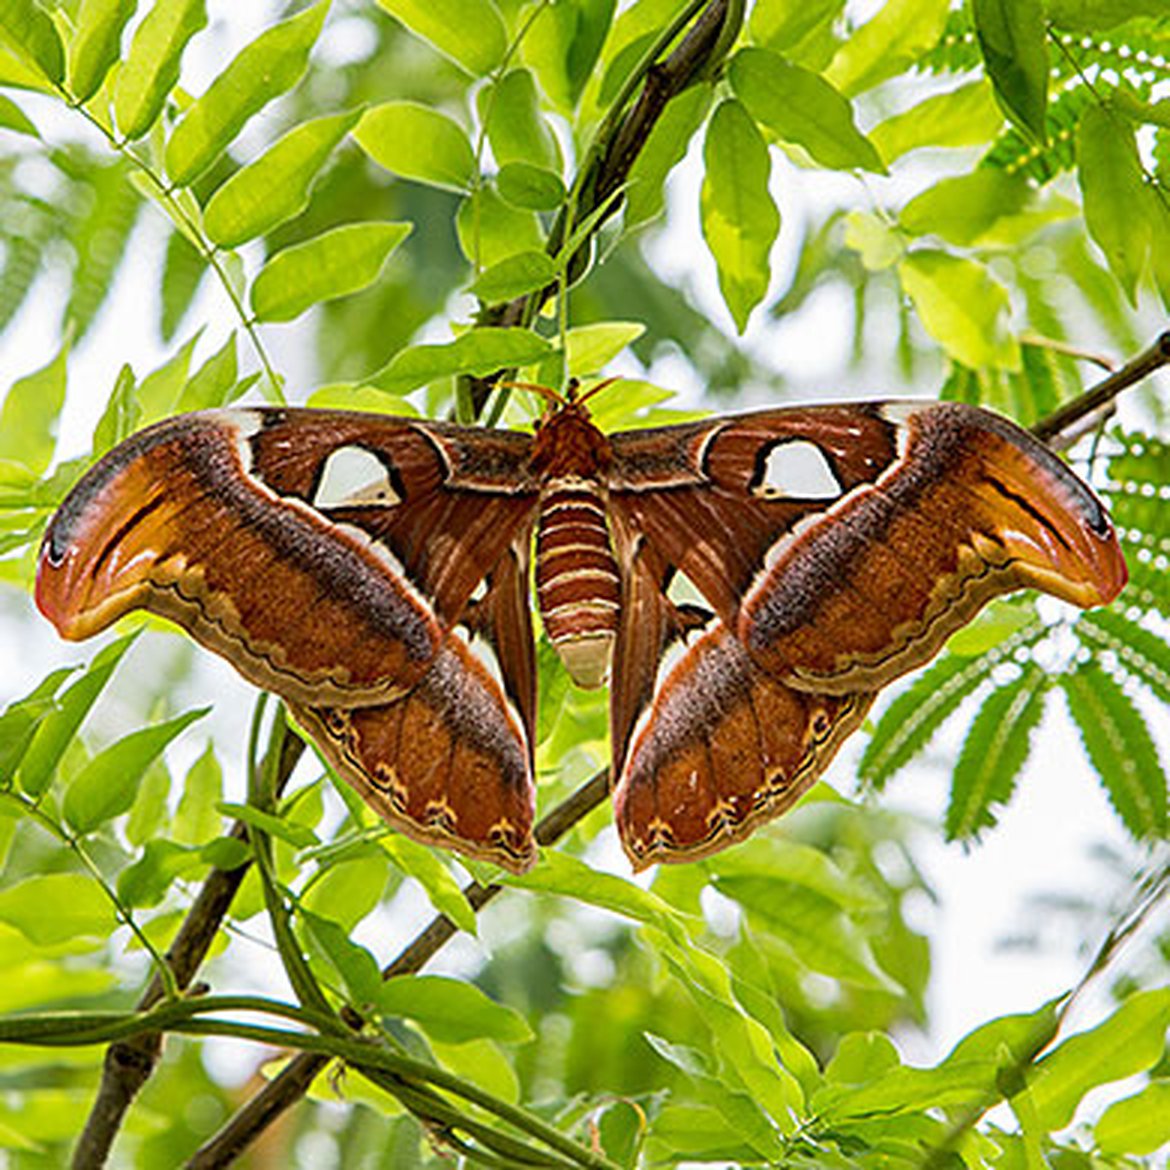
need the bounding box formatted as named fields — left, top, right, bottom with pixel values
left=204, top=110, right=362, bottom=248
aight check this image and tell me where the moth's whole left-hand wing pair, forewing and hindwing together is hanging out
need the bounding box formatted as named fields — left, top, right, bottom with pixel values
left=36, top=410, right=537, bottom=868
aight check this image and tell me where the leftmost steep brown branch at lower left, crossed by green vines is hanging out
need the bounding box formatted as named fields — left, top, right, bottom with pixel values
left=73, top=735, right=304, bottom=1170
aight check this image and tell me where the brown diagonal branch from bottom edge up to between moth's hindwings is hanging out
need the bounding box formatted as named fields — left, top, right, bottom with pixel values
left=186, top=772, right=608, bottom=1170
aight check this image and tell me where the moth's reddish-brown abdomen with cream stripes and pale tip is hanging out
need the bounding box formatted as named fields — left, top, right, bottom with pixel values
left=536, top=477, right=621, bottom=688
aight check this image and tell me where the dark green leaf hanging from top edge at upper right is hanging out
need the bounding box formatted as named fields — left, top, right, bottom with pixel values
left=971, top=0, right=1048, bottom=143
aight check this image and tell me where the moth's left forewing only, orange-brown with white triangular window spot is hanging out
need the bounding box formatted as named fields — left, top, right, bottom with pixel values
left=37, top=410, right=536, bottom=704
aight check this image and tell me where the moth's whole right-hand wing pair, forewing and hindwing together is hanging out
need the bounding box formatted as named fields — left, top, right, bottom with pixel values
left=608, top=404, right=1126, bottom=868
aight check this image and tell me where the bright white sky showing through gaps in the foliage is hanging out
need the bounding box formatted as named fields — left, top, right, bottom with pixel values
left=0, top=0, right=1170, bottom=1095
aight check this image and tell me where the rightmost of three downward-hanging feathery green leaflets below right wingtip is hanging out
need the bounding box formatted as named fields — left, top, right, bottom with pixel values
left=1061, top=662, right=1166, bottom=837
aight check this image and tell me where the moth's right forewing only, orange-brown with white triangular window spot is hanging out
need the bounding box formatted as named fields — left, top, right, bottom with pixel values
left=610, top=402, right=1126, bottom=693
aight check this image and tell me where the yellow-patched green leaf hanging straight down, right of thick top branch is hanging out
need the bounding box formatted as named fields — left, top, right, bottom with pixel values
left=700, top=99, right=780, bottom=333
